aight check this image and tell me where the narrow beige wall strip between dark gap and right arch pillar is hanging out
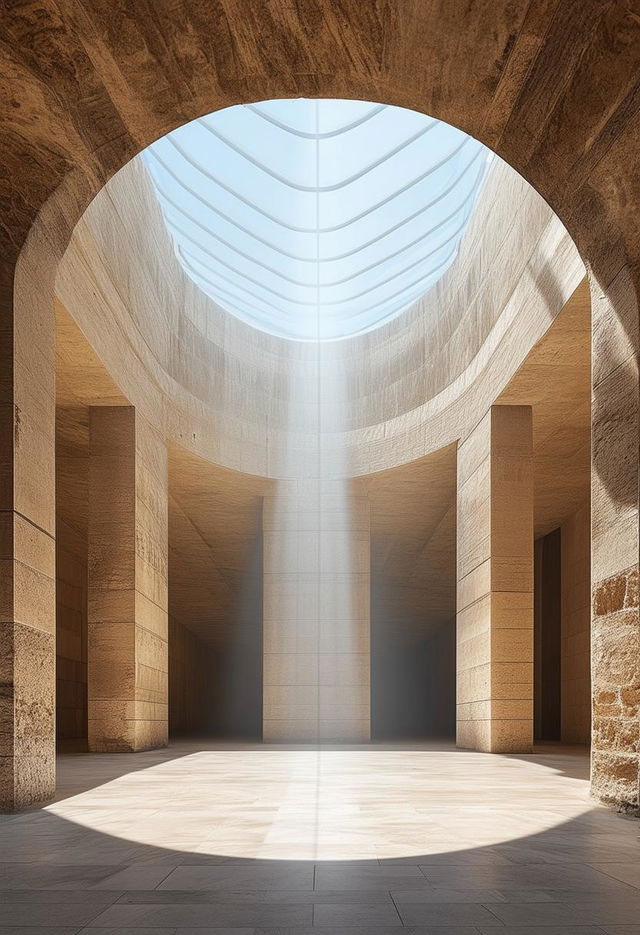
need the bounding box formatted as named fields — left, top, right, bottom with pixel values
left=561, top=503, right=591, bottom=744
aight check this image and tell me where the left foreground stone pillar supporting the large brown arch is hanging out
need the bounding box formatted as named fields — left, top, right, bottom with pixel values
left=0, top=249, right=55, bottom=811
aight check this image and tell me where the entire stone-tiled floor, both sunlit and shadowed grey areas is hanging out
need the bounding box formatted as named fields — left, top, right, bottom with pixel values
left=0, top=742, right=640, bottom=935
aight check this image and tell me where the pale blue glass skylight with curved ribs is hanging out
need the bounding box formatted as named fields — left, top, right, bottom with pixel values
left=143, top=99, right=490, bottom=340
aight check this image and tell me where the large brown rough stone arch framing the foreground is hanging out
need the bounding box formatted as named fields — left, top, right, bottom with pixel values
left=0, top=0, right=640, bottom=805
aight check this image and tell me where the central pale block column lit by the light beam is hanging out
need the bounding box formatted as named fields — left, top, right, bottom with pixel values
left=263, top=479, right=370, bottom=742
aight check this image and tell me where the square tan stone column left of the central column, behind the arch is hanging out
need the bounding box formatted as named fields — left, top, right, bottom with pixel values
left=87, top=406, right=168, bottom=752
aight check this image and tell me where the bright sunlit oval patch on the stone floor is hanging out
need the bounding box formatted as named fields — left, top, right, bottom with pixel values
left=45, top=745, right=593, bottom=861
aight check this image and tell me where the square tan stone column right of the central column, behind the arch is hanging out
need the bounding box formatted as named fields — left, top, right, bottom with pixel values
left=457, top=406, right=533, bottom=753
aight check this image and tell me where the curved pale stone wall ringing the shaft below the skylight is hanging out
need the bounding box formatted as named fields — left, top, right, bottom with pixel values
left=57, top=160, right=584, bottom=478
